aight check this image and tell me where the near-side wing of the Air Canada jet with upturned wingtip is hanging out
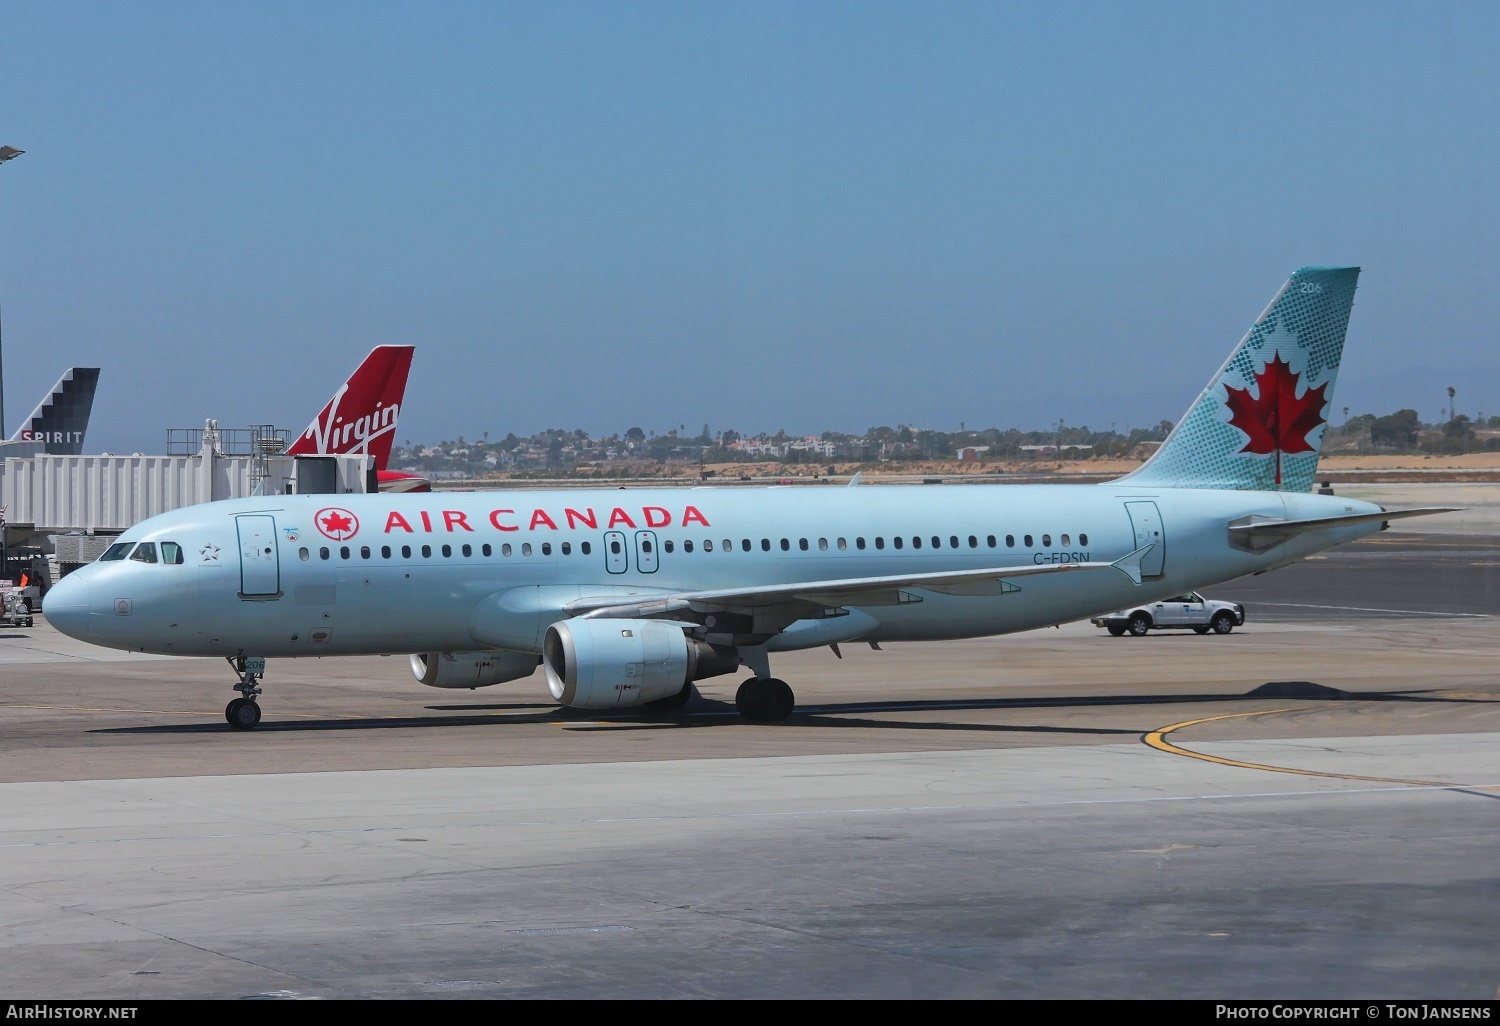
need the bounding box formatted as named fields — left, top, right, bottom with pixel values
left=566, top=545, right=1152, bottom=618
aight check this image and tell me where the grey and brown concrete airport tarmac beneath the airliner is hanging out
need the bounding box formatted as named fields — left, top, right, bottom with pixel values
left=0, top=485, right=1500, bottom=1001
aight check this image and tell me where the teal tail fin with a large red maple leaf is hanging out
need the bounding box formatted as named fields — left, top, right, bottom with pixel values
left=1121, top=267, right=1359, bottom=492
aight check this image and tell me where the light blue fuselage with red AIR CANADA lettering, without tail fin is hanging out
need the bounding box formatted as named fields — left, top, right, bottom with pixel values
left=47, top=482, right=1382, bottom=657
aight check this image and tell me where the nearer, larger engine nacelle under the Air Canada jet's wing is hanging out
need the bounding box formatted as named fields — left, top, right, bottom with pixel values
left=542, top=617, right=740, bottom=710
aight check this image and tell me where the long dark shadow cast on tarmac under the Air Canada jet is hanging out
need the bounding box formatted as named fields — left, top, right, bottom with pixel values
left=90, top=681, right=1494, bottom=737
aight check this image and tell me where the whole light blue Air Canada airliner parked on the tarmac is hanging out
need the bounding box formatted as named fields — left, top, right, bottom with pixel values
left=42, top=267, right=1446, bottom=729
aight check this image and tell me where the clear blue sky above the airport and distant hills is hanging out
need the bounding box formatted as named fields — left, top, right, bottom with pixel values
left=0, top=0, right=1500, bottom=453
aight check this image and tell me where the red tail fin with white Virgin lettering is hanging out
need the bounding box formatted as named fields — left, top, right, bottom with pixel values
left=287, top=345, right=416, bottom=471
